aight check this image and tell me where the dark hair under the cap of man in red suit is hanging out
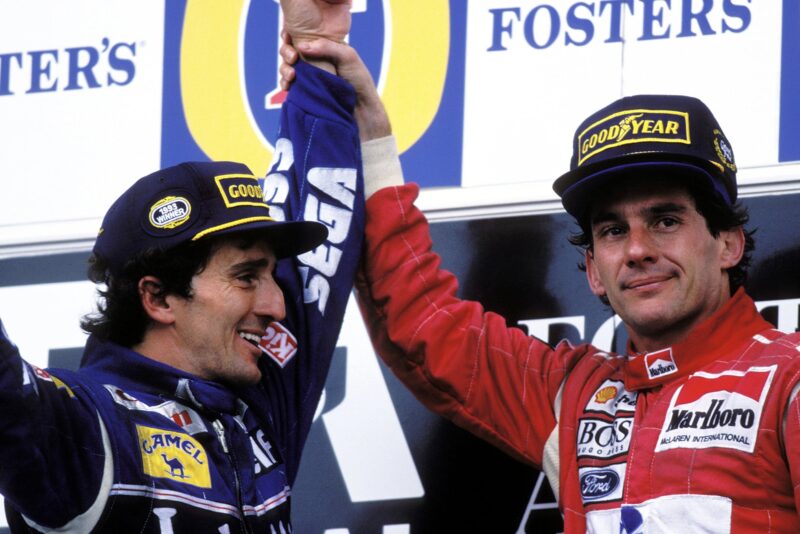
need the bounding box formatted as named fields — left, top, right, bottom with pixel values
left=569, top=177, right=756, bottom=304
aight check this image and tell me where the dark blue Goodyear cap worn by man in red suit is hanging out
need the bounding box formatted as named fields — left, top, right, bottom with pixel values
left=553, top=95, right=737, bottom=219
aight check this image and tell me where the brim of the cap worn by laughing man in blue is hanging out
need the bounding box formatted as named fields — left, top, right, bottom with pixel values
left=206, top=221, right=328, bottom=259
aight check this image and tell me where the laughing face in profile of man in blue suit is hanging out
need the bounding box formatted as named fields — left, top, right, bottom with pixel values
left=160, top=241, right=285, bottom=386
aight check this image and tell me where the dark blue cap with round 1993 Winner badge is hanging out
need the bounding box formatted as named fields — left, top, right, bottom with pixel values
left=93, top=161, right=328, bottom=273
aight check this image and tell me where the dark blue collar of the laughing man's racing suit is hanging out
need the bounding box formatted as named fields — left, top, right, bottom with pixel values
left=81, top=336, right=241, bottom=414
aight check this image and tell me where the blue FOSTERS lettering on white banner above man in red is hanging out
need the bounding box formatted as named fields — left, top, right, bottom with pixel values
left=487, top=0, right=752, bottom=52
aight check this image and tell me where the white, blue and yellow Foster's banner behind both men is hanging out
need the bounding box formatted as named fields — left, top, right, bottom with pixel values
left=0, top=0, right=800, bottom=253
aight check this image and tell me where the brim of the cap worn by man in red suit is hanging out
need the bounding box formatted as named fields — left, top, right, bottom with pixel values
left=553, top=155, right=732, bottom=220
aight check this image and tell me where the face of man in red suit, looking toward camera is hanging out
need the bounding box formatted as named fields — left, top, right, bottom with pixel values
left=586, top=180, right=744, bottom=351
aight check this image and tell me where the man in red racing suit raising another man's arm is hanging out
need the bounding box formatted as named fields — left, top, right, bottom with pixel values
left=284, top=22, right=800, bottom=533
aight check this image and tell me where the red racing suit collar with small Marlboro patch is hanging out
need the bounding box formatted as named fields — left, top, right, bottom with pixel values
left=625, top=288, right=773, bottom=391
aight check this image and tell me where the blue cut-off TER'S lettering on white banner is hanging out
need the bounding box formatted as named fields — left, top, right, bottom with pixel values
left=0, top=37, right=137, bottom=96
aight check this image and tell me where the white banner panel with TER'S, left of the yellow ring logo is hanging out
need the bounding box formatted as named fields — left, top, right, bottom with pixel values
left=0, top=0, right=164, bottom=239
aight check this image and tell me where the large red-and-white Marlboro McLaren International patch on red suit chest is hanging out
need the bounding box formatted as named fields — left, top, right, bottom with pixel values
left=656, top=365, right=776, bottom=452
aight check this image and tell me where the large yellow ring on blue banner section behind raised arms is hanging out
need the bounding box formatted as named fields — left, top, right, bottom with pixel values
left=180, top=0, right=450, bottom=175
